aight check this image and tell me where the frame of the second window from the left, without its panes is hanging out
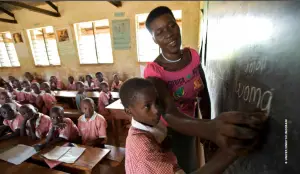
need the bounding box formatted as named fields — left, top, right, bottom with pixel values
left=26, top=26, right=61, bottom=67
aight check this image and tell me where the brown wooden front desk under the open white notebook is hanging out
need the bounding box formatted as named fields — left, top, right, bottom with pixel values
left=32, top=142, right=110, bottom=174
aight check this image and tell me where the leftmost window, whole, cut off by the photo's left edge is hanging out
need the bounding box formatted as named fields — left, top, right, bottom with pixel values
left=0, top=32, right=20, bottom=67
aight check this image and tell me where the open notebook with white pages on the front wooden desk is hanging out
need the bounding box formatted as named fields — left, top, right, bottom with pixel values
left=43, top=146, right=85, bottom=163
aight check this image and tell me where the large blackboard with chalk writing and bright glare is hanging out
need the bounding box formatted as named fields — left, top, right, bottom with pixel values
left=203, top=1, right=300, bottom=174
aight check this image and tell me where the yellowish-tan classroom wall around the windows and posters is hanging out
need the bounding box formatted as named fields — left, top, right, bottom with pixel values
left=0, top=1, right=200, bottom=81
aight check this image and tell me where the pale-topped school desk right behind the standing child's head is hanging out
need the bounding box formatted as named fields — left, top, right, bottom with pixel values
left=105, top=99, right=131, bottom=146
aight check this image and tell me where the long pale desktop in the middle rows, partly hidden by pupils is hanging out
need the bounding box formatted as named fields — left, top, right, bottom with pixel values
left=53, top=91, right=120, bottom=98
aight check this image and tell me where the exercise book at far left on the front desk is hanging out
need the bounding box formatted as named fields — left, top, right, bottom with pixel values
left=0, top=144, right=37, bottom=165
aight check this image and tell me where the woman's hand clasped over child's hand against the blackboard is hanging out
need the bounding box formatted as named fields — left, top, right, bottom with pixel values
left=211, top=111, right=268, bottom=154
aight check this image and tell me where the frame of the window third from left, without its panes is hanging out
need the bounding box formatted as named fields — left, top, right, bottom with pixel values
left=73, top=18, right=115, bottom=66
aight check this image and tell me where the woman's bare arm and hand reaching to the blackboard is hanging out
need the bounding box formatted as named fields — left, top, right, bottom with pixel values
left=147, top=77, right=267, bottom=154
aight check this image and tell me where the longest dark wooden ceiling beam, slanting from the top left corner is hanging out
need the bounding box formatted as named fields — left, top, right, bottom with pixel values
left=1, top=1, right=61, bottom=17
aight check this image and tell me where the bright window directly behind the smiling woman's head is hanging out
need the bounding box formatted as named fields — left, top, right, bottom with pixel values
left=136, top=10, right=182, bottom=62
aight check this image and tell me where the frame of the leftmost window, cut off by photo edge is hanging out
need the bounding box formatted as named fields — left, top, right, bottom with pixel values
left=0, top=31, right=21, bottom=69
